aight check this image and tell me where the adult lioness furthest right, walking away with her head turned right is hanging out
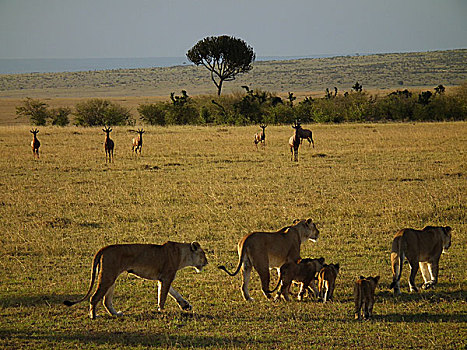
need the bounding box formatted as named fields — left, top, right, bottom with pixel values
left=389, top=226, right=452, bottom=294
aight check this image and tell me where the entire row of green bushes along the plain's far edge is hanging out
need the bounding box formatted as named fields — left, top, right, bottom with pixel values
left=17, top=83, right=467, bottom=126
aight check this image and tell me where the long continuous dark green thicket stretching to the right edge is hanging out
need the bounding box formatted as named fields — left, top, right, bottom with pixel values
left=133, top=84, right=467, bottom=125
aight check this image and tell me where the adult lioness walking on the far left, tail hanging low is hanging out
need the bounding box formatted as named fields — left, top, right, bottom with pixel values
left=64, top=241, right=208, bottom=319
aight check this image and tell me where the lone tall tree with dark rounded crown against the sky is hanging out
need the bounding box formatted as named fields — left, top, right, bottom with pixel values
left=186, top=35, right=256, bottom=95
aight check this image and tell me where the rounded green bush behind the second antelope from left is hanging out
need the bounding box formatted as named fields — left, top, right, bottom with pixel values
left=75, top=98, right=134, bottom=126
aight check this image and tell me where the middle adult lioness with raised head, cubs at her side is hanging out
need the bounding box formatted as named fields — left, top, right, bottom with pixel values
left=219, top=219, right=319, bottom=300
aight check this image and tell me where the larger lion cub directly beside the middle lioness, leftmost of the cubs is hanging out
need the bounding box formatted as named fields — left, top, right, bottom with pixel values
left=272, top=258, right=324, bottom=301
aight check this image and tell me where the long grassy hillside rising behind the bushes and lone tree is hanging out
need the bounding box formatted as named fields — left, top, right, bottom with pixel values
left=0, top=49, right=467, bottom=98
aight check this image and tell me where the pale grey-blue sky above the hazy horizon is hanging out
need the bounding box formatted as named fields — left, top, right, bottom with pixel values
left=0, top=0, right=467, bottom=58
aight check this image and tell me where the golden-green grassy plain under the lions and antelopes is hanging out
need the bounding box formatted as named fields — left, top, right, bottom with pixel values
left=0, top=122, right=467, bottom=349
